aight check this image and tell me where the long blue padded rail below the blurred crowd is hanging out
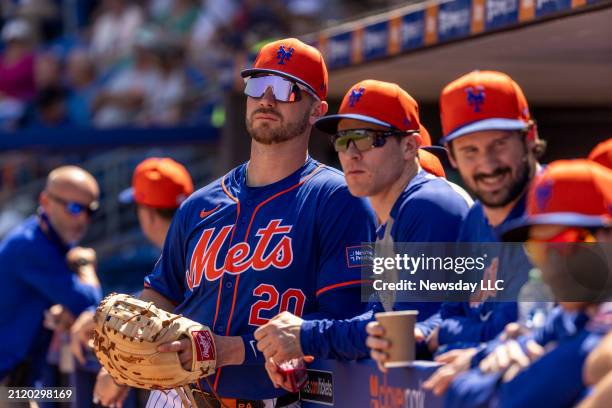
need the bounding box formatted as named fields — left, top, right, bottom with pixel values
left=0, top=126, right=220, bottom=151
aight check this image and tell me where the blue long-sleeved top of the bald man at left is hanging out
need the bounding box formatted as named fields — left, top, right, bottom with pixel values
left=0, top=214, right=102, bottom=380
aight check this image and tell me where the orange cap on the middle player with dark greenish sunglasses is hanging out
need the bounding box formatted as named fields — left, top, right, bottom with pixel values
left=315, top=79, right=420, bottom=135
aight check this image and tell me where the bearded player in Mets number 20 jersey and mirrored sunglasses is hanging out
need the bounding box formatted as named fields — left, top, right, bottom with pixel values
left=142, top=39, right=375, bottom=407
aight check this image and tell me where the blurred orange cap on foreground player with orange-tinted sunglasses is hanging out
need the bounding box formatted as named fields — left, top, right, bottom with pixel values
left=503, top=159, right=612, bottom=241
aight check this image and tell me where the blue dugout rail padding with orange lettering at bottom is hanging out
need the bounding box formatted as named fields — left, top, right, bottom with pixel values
left=300, top=360, right=444, bottom=408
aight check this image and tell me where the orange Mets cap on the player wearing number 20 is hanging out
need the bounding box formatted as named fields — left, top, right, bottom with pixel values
left=240, top=38, right=328, bottom=100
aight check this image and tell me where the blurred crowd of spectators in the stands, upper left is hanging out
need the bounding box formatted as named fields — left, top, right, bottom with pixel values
left=0, top=0, right=412, bottom=131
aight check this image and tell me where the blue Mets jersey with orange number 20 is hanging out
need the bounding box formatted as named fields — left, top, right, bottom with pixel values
left=145, top=158, right=375, bottom=399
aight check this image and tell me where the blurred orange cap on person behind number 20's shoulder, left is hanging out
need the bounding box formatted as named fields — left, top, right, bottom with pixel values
left=119, top=157, right=193, bottom=209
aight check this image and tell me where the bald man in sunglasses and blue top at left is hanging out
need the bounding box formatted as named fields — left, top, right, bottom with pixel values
left=0, top=166, right=101, bottom=386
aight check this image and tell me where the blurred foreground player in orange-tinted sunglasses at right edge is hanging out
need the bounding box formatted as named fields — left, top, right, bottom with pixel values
left=446, top=160, right=612, bottom=407
